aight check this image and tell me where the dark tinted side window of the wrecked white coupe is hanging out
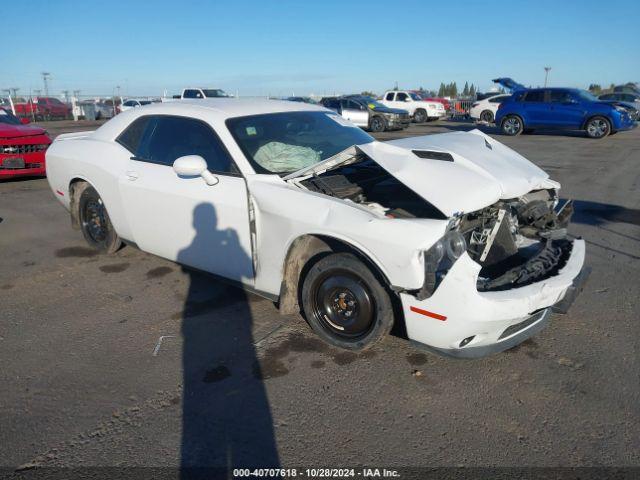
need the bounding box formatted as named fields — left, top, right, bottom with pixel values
left=137, top=116, right=239, bottom=174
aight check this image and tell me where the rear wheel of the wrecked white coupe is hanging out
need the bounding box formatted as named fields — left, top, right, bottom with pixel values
left=78, top=184, right=122, bottom=253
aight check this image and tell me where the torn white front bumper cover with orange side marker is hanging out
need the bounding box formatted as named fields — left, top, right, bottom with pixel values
left=400, top=240, right=589, bottom=358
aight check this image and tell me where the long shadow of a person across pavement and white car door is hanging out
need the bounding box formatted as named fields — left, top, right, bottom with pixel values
left=177, top=203, right=280, bottom=479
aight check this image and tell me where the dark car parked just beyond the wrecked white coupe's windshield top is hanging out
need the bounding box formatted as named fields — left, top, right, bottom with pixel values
left=320, top=95, right=411, bottom=132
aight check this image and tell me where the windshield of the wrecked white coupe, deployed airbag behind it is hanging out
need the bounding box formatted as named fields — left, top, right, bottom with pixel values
left=227, top=112, right=373, bottom=175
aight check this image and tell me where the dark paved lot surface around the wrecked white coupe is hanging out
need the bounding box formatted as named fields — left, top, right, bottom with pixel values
left=0, top=121, right=640, bottom=474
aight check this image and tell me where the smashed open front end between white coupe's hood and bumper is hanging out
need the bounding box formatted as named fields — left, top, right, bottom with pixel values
left=457, top=189, right=573, bottom=292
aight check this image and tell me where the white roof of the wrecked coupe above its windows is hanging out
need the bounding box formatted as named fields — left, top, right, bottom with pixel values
left=94, top=98, right=334, bottom=140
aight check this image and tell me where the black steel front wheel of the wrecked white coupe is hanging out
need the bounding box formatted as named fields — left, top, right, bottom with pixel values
left=302, top=253, right=393, bottom=350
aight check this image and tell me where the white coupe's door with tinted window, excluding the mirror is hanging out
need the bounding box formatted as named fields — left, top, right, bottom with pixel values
left=118, top=115, right=253, bottom=285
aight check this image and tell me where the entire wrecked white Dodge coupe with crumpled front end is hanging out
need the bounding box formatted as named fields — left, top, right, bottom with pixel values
left=46, top=99, right=588, bottom=358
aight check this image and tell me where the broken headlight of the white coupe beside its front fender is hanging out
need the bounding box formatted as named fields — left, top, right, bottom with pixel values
left=416, top=230, right=467, bottom=300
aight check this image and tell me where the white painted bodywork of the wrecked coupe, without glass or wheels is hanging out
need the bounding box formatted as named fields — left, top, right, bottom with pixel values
left=46, top=99, right=584, bottom=356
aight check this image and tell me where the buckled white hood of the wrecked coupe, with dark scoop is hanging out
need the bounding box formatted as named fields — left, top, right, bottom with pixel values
left=357, top=129, right=560, bottom=216
